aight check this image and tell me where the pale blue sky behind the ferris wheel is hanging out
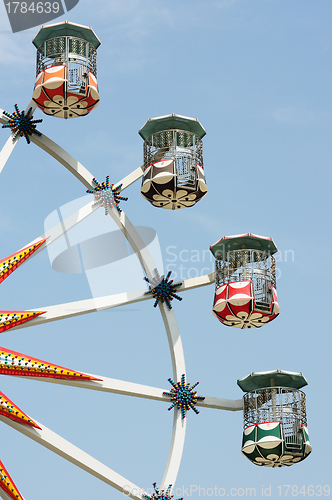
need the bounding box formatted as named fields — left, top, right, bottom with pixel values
left=0, top=0, right=332, bottom=500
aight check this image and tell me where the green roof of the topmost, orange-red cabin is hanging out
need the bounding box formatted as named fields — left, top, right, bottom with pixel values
left=32, top=21, right=101, bottom=49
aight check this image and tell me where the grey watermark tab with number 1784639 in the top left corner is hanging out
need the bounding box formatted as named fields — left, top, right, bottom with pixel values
left=3, top=0, right=79, bottom=33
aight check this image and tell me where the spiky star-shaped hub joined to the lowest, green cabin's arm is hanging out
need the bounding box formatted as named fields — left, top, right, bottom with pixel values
left=163, top=374, right=205, bottom=418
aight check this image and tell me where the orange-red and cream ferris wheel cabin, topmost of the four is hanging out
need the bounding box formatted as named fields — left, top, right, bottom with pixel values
left=32, top=21, right=100, bottom=119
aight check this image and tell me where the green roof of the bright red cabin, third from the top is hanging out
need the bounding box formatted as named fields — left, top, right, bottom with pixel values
left=210, top=233, right=278, bottom=258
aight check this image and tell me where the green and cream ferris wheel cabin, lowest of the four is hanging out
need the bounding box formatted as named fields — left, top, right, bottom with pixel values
left=237, top=370, right=312, bottom=467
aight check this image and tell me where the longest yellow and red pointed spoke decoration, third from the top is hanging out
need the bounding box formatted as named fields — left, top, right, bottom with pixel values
left=0, top=347, right=101, bottom=380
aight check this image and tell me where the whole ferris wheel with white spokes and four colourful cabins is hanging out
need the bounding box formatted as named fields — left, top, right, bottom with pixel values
left=0, top=21, right=311, bottom=500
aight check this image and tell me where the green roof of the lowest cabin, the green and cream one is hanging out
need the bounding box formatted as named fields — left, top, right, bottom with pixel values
left=237, top=370, right=308, bottom=392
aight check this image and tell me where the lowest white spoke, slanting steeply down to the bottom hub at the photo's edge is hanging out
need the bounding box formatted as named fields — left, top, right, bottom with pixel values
left=0, top=415, right=142, bottom=500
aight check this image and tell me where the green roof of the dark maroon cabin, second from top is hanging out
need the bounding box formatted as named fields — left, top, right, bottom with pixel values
left=138, top=113, right=206, bottom=140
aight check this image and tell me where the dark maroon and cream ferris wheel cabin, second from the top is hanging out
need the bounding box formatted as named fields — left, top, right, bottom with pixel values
left=139, top=114, right=207, bottom=210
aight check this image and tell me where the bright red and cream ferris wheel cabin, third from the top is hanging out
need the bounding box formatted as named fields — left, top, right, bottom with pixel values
left=210, top=233, right=280, bottom=329
